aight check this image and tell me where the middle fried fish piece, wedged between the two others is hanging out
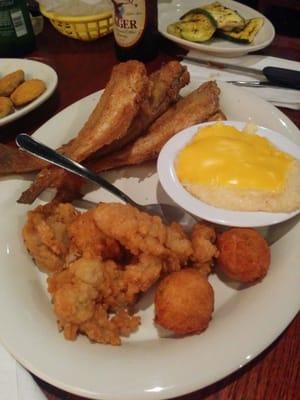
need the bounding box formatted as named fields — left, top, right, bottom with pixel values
left=92, top=61, right=190, bottom=158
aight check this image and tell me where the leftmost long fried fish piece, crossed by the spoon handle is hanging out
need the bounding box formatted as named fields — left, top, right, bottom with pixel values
left=18, top=61, right=149, bottom=204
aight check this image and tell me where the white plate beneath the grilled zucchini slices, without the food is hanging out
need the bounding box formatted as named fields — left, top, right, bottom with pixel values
left=158, top=0, right=275, bottom=57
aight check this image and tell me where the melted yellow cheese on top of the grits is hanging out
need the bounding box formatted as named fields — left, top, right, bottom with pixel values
left=175, top=123, right=293, bottom=192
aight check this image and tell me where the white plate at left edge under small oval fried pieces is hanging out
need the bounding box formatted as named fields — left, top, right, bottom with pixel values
left=0, top=58, right=57, bottom=126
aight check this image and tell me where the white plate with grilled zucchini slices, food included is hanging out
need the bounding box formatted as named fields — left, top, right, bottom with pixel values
left=159, top=0, right=275, bottom=57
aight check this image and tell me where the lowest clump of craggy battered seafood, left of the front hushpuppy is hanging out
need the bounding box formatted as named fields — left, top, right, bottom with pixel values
left=48, top=255, right=162, bottom=345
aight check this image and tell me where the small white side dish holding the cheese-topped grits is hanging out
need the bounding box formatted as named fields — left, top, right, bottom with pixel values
left=157, top=121, right=300, bottom=227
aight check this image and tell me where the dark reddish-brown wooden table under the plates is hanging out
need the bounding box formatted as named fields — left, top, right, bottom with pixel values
left=0, top=23, right=300, bottom=400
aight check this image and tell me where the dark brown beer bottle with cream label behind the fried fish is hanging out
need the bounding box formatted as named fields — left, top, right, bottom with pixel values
left=112, top=0, right=158, bottom=61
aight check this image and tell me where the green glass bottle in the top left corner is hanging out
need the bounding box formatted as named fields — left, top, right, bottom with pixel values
left=0, top=0, right=35, bottom=57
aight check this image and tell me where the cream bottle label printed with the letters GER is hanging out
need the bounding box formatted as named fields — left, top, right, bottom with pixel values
left=112, top=0, right=146, bottom=47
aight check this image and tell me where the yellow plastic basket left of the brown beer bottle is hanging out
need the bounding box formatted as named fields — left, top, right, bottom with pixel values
left=40, top=6, right=112, bottom=41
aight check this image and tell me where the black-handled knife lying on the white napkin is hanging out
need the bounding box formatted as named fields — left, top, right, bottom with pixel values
left=180, top=55, right=300, bottom=90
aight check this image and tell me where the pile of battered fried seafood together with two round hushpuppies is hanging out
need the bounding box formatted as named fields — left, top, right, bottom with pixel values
left=22, top=202, right=270, bottom=345
